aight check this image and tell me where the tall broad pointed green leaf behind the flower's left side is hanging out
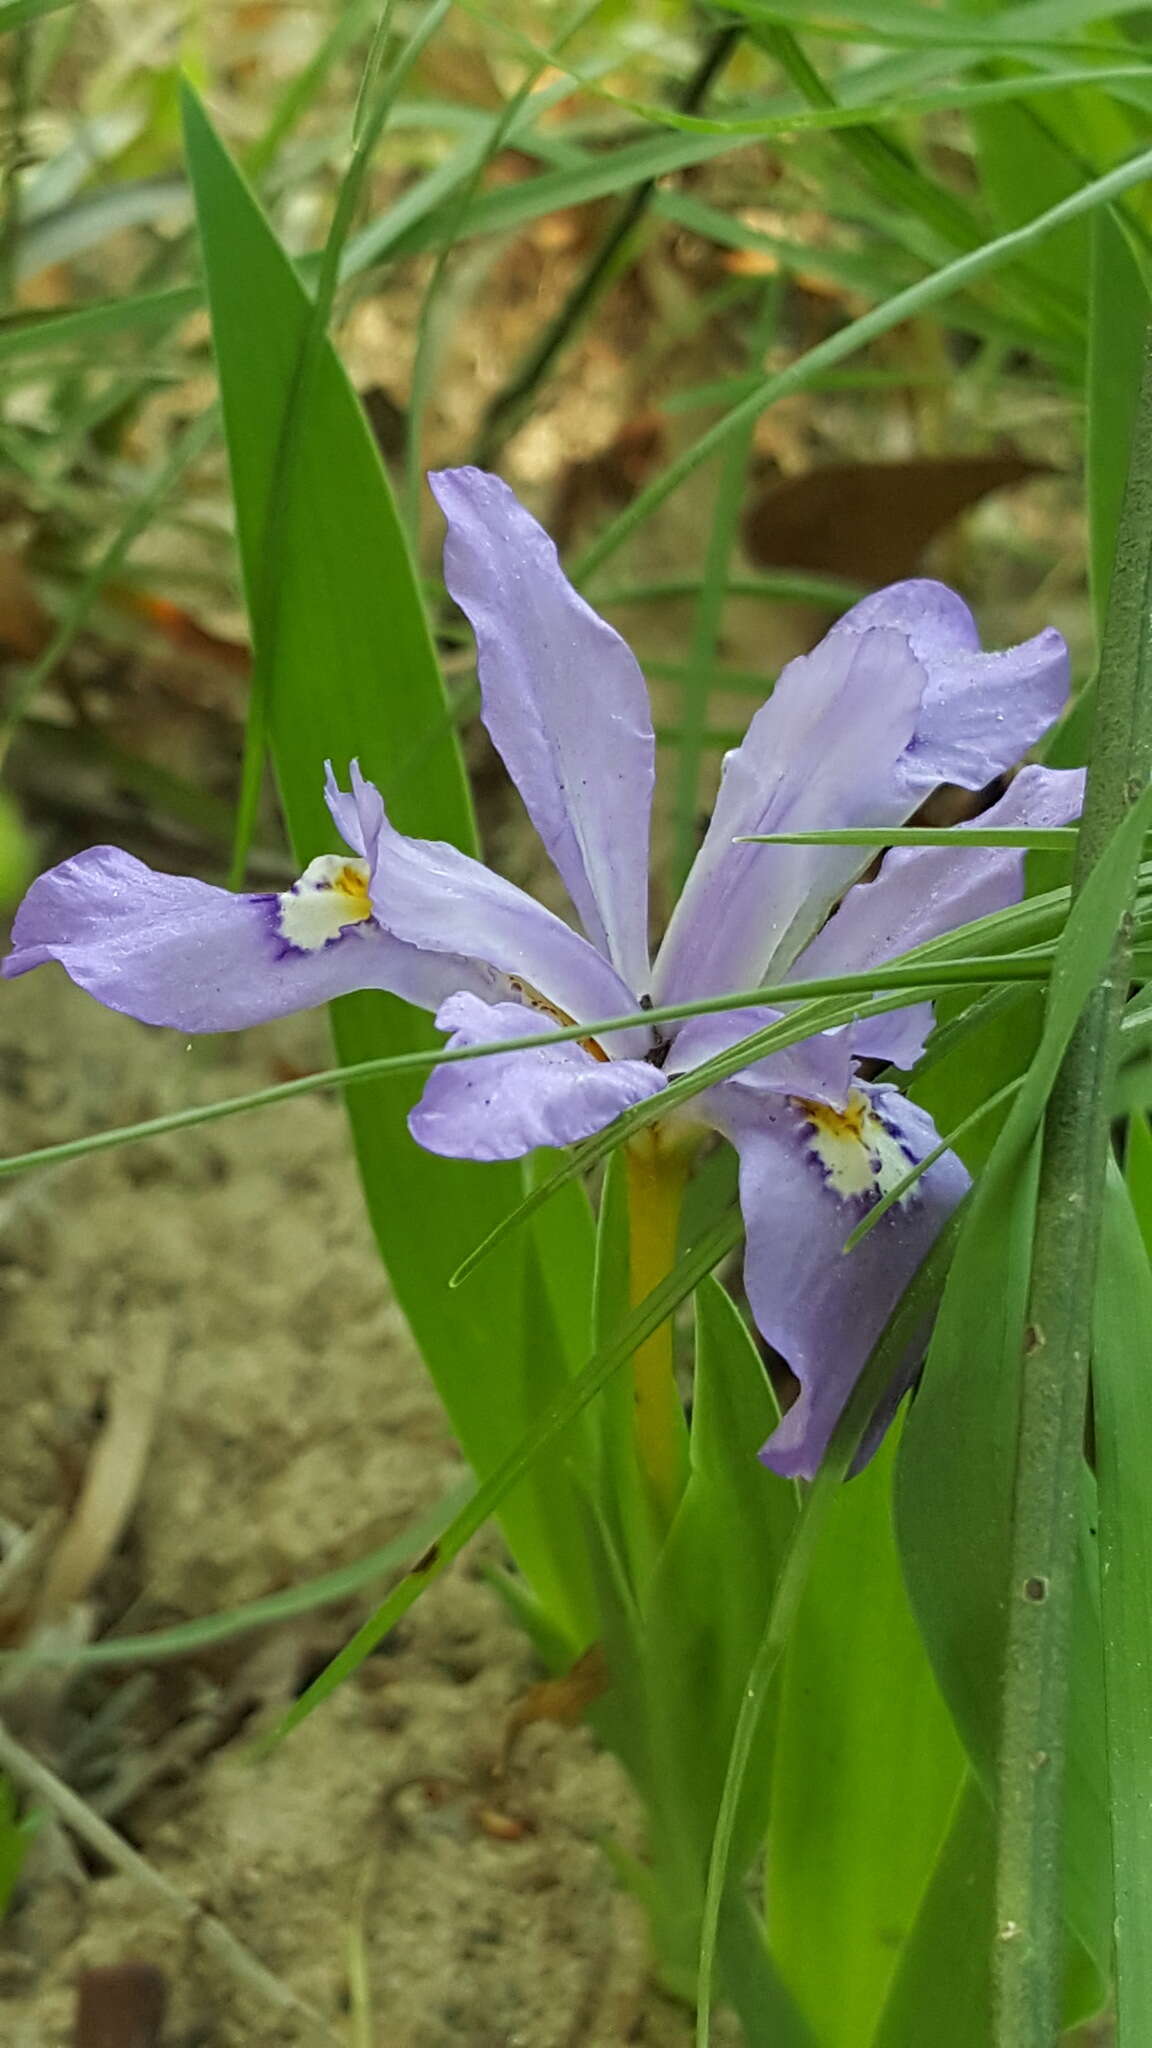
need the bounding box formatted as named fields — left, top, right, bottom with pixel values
left=187, top=96, right=584, bottom=1634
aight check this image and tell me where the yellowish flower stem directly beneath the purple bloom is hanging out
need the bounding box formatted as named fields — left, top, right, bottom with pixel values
left=627, top=1124, right=691, bottom=1530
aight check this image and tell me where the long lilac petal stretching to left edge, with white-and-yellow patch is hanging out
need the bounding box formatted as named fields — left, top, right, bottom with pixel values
left=0, top=846, right=471, bottom=1032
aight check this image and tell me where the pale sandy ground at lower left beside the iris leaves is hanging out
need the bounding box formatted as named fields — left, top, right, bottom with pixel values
left=0, top=969, right=729, bottom=2048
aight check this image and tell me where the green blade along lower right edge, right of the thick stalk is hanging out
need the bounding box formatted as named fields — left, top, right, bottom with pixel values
left=1093, top=1163, right=1152, bottom=2048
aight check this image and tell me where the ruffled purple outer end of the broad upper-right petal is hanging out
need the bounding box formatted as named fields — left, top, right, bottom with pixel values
left=832, top=578, right=1068, bottom=797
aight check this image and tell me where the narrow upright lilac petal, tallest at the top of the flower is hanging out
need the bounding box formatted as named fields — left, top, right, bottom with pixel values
left=428, top=469, right=654, bottom=991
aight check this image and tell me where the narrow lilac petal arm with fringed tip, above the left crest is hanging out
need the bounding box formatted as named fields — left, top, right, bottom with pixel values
left=328, top=764, right=648, bottom=1053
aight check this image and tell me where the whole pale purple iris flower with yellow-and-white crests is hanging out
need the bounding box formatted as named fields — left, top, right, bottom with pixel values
left=2, top=469, right=1082, bottom=1477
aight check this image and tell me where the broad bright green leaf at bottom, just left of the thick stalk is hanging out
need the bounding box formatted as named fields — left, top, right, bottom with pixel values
left=767, top=1436, right=965, bottom=2048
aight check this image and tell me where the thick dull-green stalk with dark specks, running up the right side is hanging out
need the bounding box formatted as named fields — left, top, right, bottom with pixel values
left=992, top=319, right=1152, bottom=2048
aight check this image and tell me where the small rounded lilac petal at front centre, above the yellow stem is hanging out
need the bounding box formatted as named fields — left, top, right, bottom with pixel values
left=408, top=993, right=666, bottom=1159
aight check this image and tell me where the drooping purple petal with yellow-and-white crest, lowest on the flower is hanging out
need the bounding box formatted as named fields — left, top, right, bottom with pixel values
left=715, top=1083, right=968, bottom=1479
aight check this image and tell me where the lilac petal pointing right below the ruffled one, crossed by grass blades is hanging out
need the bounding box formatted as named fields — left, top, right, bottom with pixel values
left=793, top=768, right=1084, bottom=1067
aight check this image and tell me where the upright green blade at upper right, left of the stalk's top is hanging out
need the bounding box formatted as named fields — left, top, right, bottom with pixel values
left=1084, top=207, right=1150, bottom=633
